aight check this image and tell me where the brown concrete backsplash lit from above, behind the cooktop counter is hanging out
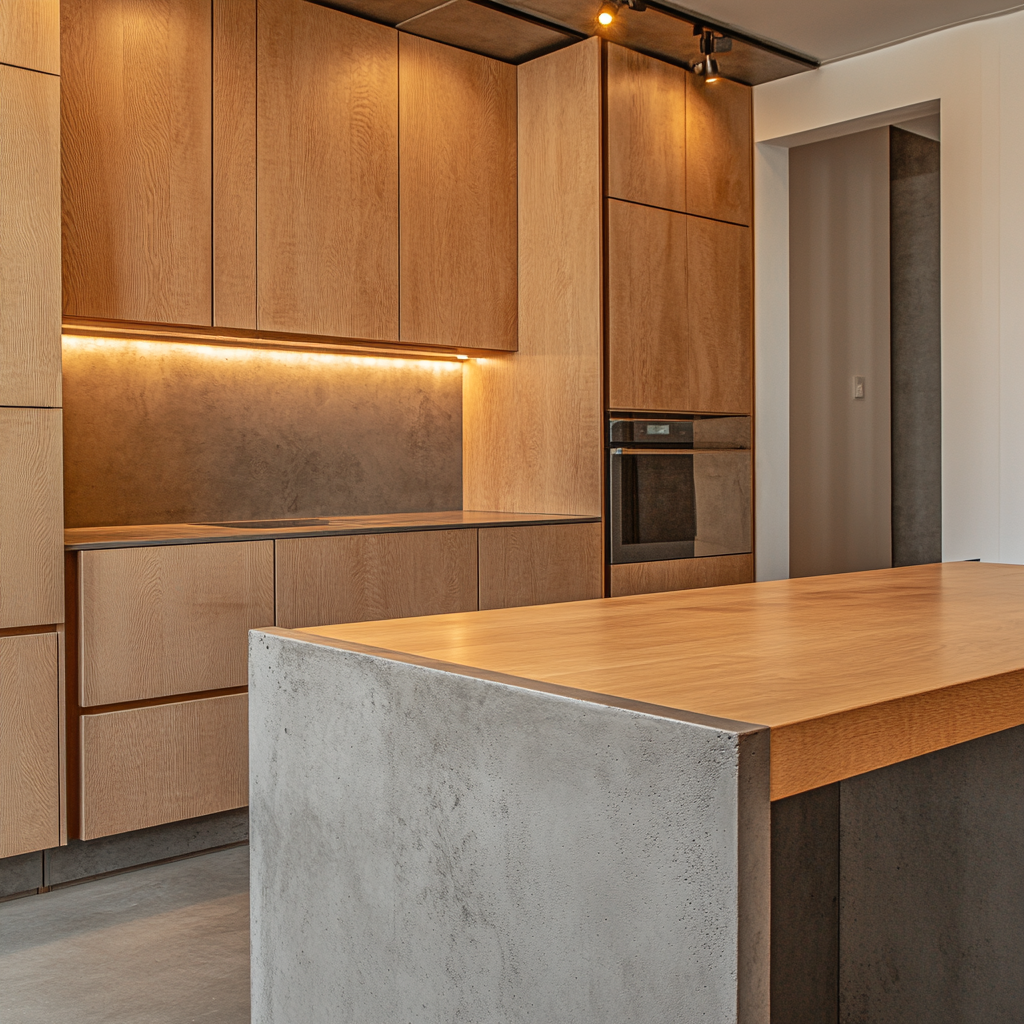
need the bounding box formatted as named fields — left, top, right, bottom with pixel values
left=63, top=338, right=462, bottom=527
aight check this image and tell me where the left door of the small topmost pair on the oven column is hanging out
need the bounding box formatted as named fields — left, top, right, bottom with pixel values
left=605, top=43, right=689, bottom=213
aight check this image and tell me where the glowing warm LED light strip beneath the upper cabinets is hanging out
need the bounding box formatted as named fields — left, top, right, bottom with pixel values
left=61, top=334, right=468, bottom=373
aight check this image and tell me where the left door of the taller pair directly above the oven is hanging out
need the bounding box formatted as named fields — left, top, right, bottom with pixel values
left=607, top=200, right=692, bottom=412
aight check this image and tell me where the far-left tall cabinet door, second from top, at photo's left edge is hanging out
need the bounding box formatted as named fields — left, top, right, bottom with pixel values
left=0, top=66, right=60, bottom=407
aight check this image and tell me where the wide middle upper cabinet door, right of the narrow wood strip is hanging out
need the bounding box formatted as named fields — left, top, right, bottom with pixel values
left=256, top=0, right=398, bottom=341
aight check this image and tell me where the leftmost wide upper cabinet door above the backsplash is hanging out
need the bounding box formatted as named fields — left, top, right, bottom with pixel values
left=60, top=0, right=212, bottom=326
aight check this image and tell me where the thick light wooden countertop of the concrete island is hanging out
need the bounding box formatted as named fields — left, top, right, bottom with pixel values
left=300, top=562, right=1024, bottom=800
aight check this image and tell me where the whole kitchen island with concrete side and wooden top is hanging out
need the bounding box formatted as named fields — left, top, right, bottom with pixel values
left=250, top=563, right=1024, bottom=1024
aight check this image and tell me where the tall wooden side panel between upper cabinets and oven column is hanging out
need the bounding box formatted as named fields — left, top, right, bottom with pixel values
left=463, top=38, right=603, bottom=515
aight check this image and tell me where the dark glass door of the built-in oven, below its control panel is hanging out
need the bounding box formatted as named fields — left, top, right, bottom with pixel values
left=609, top=449, right=751, bottom=564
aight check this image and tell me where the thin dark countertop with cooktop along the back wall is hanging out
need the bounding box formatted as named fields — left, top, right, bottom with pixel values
left=65, top=510, right=600, bottom=551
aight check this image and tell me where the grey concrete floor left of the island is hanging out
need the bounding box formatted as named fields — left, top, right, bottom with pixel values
left=0, top=847, right=249, bottom=1024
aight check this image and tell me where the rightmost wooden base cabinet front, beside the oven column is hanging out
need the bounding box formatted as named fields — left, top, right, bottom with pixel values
left=479, top=522, right=604, bottom=608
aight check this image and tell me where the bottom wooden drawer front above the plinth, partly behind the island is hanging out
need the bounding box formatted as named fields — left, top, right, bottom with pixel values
left=80, top=693, right=249, bottom=839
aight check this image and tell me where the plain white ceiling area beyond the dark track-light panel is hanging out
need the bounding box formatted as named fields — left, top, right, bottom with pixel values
left=663, top=0, right=1024, bottom=61
